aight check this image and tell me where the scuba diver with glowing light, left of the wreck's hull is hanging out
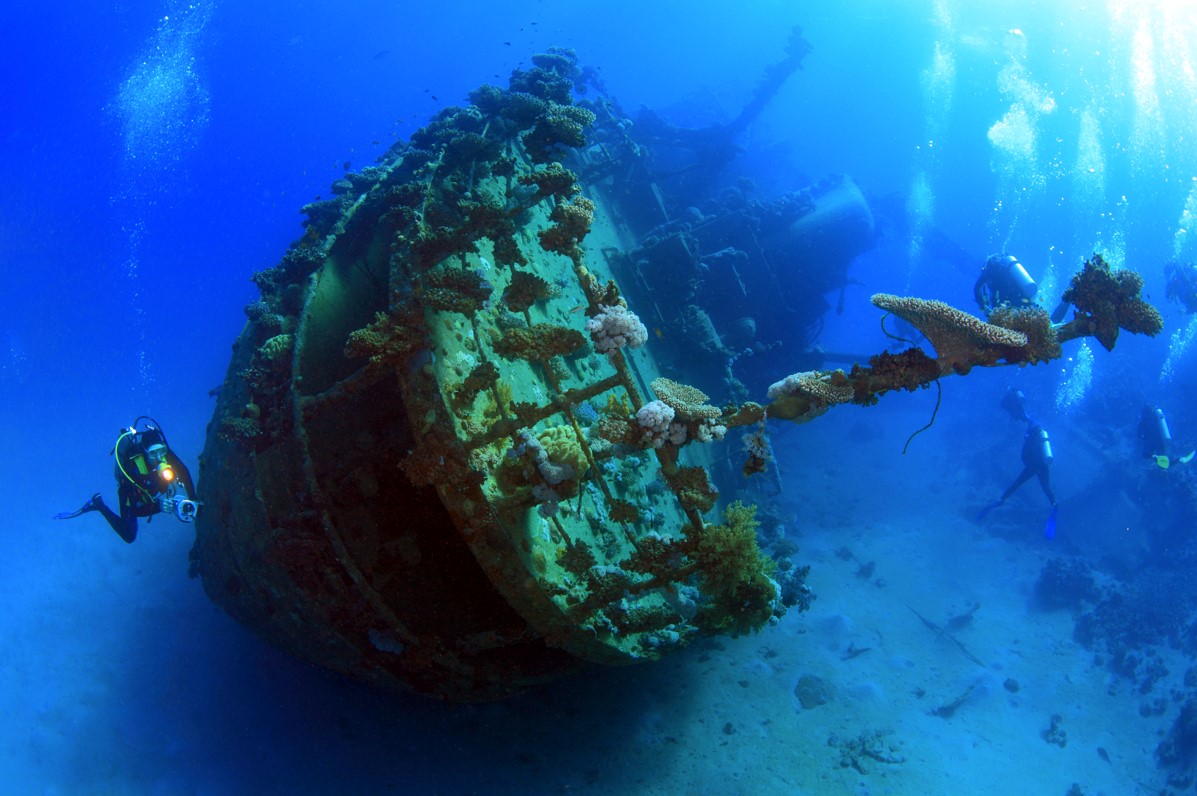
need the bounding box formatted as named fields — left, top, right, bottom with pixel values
left=54, top=417, right=200, bottom=545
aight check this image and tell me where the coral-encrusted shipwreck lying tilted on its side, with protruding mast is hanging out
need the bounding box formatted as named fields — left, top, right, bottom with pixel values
left=192, top=50, right=1154, bottom=700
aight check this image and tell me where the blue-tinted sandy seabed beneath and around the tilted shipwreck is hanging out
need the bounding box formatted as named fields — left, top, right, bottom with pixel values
left=0, top=411, right=1186, bottom=796
